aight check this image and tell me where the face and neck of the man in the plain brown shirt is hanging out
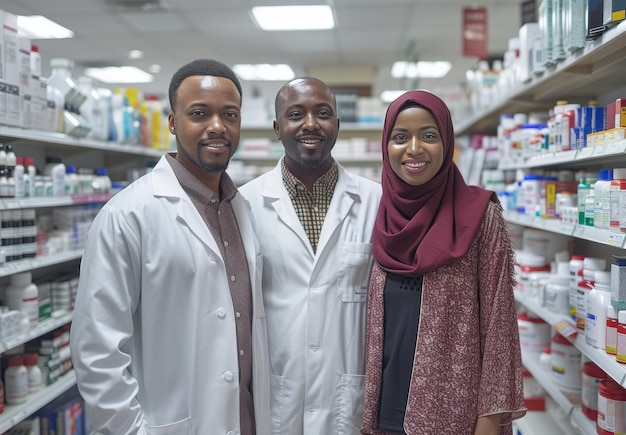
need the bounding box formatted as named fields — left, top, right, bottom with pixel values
left=169, top=75, right=241, bottom=192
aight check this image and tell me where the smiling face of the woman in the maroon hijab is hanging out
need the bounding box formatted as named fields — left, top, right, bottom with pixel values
left=387, top=106, right=444, bottom=186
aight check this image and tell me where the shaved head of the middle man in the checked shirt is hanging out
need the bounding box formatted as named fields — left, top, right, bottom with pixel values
left=274, top=78, right=339, bottom=177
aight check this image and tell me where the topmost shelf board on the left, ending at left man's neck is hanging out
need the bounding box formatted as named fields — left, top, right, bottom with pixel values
left=0, top=126, right=165, bottom=157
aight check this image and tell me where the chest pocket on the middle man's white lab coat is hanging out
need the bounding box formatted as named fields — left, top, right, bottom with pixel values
left=337, top=242, right=373, bottom=302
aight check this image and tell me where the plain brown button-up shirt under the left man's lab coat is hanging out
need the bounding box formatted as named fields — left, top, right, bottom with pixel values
left=166, top=154, right=255, bottom=435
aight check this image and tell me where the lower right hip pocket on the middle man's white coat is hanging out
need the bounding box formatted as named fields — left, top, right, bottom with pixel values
left=333, top=375, right=365, bottom=435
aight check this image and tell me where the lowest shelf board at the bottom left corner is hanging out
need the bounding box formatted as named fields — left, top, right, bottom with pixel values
left=0, top=370, right=76, bottom=433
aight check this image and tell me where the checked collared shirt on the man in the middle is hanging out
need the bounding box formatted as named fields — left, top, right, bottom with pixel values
left=280, top=159, right=339, bottom=252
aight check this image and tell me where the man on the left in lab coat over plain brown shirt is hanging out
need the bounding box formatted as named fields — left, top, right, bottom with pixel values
left=70, top=59, right=270, bottom=435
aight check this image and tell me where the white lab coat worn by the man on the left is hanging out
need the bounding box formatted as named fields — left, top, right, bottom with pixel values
left=70, top=157, right=270, bottom=435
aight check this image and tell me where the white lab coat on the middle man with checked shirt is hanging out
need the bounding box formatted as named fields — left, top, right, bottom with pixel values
left=239, top=162, right=381, bottom=435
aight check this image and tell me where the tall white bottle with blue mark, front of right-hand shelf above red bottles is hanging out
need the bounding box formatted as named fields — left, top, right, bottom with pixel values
left=585, top=271, right=611, bottom=349
